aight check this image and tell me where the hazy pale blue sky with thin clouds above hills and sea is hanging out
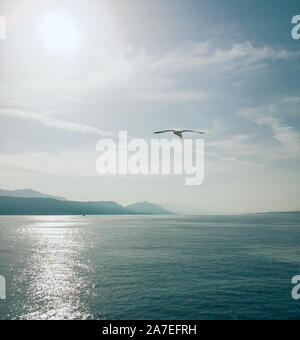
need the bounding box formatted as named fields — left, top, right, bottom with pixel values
left=0, top=0, right=300, bottom=212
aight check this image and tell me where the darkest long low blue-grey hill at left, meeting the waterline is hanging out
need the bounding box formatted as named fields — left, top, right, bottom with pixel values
left=0, top=196, right=134, bottom=215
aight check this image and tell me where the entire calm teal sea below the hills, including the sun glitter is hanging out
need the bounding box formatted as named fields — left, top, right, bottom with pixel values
left=0, top=215, right=300, bottom=320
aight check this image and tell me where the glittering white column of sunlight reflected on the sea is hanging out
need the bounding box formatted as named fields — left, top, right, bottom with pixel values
left=17, top=216, right=91, bottom=320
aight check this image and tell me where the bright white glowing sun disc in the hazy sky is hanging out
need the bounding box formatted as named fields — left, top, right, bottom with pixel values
left=40, top=13, right=80, bottom=53
